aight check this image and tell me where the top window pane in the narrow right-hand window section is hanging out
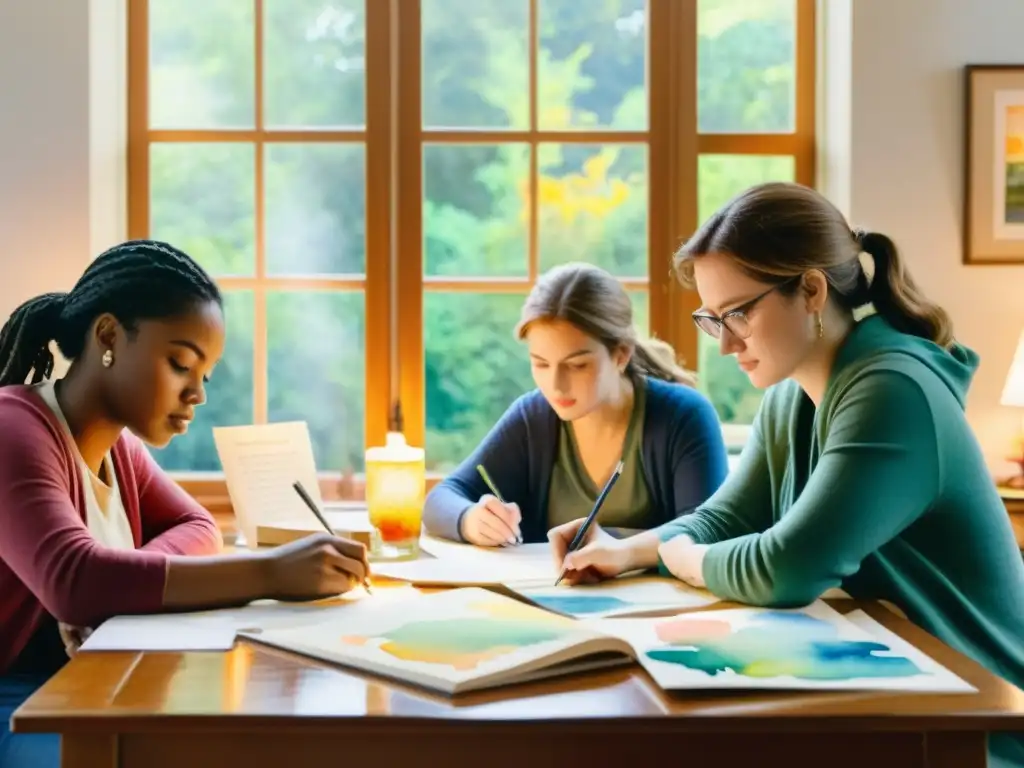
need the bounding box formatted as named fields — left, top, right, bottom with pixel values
left=697, top=0, right=797, bottom=133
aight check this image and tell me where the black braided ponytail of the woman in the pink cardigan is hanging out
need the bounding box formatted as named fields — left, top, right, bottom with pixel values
left=0, top=293, right=68, bottom=387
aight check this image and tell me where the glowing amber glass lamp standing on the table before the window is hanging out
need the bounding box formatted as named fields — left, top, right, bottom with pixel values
left=366, top=402, right=426, bottom=559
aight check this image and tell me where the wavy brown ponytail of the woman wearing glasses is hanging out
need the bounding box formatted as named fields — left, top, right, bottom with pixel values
left=853, top=229, right=953, bottom=348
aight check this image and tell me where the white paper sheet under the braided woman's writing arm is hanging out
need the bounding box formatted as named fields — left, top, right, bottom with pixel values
left=79, top=589, right=387, bottom=653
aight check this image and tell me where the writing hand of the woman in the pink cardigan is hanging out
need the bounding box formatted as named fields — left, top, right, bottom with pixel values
left=260, top=534, right=370, bottom=600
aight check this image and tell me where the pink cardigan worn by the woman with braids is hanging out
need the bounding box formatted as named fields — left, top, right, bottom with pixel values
left=0, top=386, right=222, bottom=673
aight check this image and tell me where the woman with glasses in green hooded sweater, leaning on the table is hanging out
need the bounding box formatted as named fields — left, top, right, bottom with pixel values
left=549, top=183, right=1024, bottom=766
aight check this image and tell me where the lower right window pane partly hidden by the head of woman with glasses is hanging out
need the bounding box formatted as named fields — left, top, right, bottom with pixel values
left=696, top=155, right=795, bottom=424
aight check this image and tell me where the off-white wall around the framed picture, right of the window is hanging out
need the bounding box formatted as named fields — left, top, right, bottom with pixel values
left=820, top=0, right=1024, bottom=473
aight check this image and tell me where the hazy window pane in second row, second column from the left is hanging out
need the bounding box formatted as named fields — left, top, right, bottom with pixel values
left=265, top=142, right=367, bottom=275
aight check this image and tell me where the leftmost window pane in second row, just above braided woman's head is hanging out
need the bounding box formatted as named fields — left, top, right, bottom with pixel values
left=150, top=142, right=256, bottom=275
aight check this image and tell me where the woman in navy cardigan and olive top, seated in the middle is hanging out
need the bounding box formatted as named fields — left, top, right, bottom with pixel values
left=424, top=263, right=727, bottom=547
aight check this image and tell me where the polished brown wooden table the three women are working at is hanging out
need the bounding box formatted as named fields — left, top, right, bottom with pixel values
left=12, top=600, right=1024, bottom=768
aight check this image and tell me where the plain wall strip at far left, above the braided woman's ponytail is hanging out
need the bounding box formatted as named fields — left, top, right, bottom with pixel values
left=0, top=0, right=89, bottom=317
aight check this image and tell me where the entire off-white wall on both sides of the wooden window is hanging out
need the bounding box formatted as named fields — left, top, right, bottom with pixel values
left=0, top=0, right=1024, bottom=471
